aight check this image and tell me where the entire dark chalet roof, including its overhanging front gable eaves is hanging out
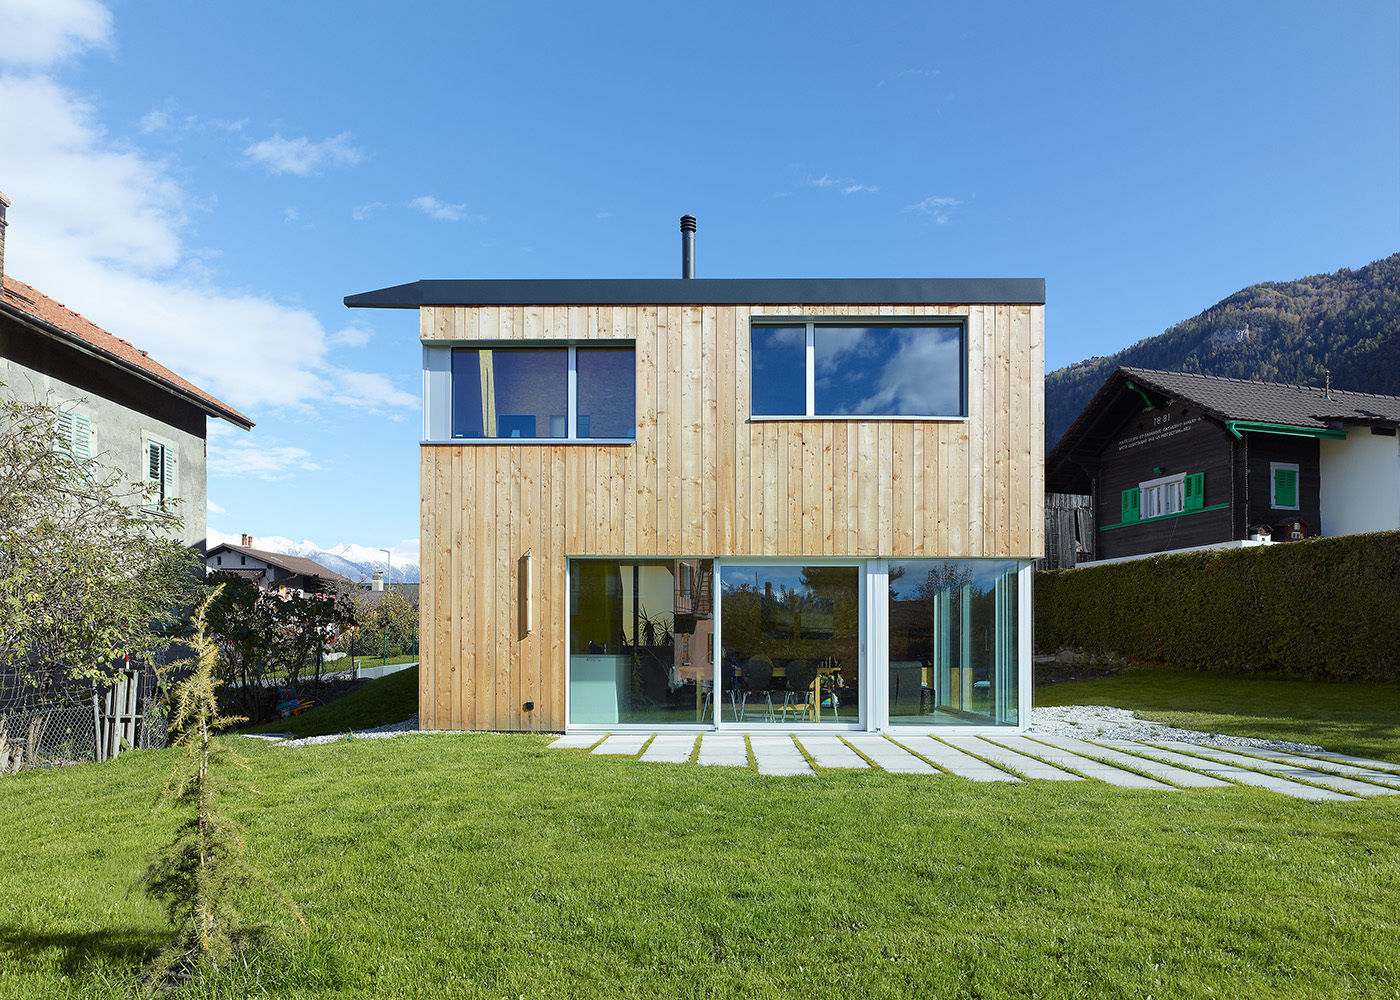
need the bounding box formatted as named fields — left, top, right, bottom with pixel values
left=1046, top=367, right=1400, bottom=493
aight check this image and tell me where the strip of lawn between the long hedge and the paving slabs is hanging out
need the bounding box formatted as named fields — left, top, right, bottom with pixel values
left=1036, top=667, right=1400, bottom=762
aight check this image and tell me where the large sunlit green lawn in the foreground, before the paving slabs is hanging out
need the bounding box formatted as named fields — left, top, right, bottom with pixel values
left=0, top=722, right=1400, bottom=1000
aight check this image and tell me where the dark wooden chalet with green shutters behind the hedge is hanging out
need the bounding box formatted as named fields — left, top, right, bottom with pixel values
left=1046, top=368, right=1400, bottom=559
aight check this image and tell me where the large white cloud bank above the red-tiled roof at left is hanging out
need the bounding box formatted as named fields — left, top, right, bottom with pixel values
left=0, top=71, right=417, bottom=412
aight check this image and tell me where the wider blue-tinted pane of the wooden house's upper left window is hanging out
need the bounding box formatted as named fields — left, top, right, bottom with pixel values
left=452, top=347, right=568, bottom=437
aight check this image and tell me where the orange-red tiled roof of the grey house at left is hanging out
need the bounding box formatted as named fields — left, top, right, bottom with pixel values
left=0, top=275, right=253, bottom=430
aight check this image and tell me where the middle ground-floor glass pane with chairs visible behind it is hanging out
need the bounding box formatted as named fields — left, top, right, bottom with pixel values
left=720, top=566, right=861, bottom=723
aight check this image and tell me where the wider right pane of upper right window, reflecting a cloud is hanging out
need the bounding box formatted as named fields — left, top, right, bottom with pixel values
left=815, top=325, right=963, bottom=416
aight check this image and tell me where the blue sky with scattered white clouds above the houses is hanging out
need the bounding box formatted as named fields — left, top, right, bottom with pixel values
left=0, top=0, right=1400, bottom=557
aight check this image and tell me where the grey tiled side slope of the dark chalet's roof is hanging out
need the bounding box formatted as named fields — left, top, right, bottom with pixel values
left=1119, top=368, right=1400, bottom=430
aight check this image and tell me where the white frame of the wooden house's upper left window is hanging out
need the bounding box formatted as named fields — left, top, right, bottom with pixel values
left=421, top=340, right=638, bottom=444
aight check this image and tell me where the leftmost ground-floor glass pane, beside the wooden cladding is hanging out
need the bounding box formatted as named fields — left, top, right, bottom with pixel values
left=568, top=559, right=714, bottom=725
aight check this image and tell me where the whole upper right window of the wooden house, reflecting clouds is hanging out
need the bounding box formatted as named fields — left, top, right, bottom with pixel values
left=749, top=318, right=967, bottom=417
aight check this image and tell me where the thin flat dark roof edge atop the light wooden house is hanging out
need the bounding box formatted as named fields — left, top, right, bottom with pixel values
left=344, top=277, right=1046, bottom=310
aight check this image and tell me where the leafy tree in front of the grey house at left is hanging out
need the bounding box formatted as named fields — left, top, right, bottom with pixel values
left=0, top=398, right=199, bottom=690
